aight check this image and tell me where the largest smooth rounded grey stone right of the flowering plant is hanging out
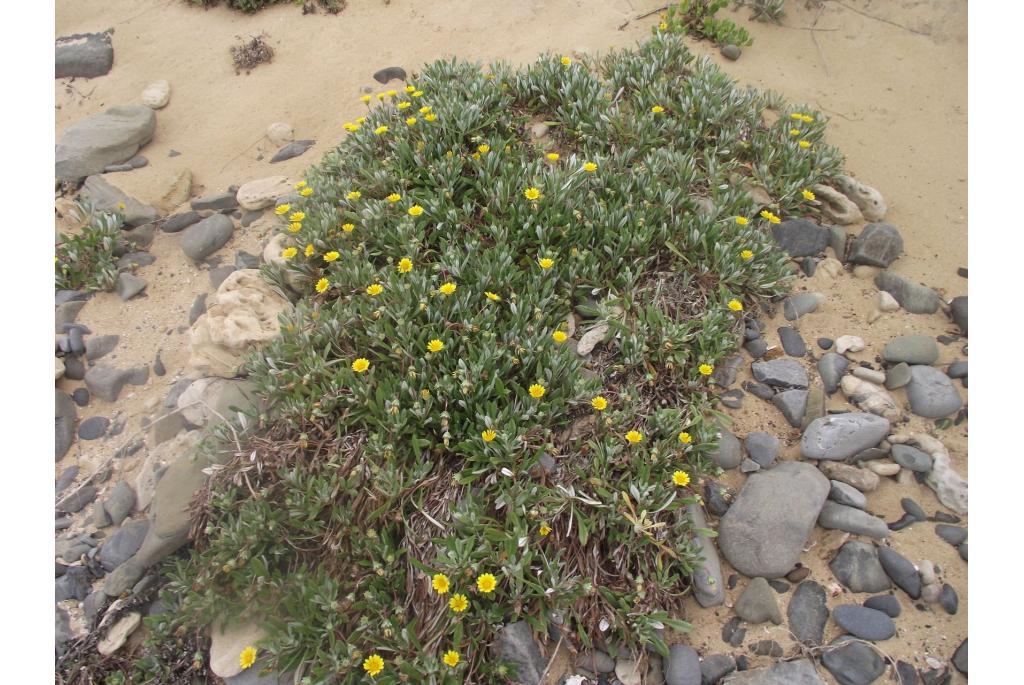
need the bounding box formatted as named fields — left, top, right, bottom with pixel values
left=719, top=462, right=828, bottom=579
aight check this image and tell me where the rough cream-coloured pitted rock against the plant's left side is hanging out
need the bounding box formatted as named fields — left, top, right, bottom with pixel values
left=188, top=268, right=292, bottom=378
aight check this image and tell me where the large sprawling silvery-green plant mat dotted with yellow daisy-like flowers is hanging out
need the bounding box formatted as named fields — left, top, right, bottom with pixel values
left=88, top=32, right=842, bottom=684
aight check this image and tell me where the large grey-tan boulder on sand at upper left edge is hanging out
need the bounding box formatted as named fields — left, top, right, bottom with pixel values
left=55, top=105, right=157, bottom=183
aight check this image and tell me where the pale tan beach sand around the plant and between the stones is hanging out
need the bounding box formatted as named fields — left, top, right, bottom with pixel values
left=54, top=0, right=968, bottom=682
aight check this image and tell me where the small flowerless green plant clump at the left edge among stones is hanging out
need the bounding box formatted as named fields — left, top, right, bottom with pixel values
left=54, top=202, right=124, bottom=290
